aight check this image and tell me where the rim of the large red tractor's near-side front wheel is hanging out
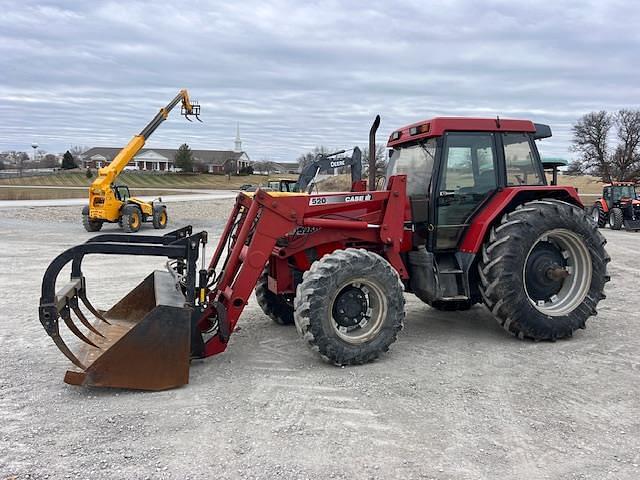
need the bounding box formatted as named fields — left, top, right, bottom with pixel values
left=329, top=278, right=387, bottom=344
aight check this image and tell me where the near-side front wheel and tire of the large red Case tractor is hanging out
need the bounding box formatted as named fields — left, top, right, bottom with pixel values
left=294, top=248, right=405, bottom=365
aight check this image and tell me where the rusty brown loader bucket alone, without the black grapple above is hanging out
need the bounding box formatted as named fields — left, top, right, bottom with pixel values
left=64, top=271, right=191, bottom=390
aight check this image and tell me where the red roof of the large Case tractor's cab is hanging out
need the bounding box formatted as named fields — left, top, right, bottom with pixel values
left=387, top=117, right=551, bottom=147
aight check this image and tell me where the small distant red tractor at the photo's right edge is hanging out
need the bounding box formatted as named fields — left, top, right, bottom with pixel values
left=591, top=182, right=640, bottom=232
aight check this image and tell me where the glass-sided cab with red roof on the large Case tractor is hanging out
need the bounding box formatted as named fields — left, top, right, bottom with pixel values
left=386, top=118, right=551, bottom=251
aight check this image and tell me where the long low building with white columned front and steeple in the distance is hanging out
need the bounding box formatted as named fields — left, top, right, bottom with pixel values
left=80, top=125, right=251, bottom=173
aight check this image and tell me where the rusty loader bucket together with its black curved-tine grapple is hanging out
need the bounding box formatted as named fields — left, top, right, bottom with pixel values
left=39, top=227, right=207, bottom=390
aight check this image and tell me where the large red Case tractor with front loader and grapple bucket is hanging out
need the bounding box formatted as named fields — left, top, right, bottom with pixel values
left=40, top=118, right=610, bottom=389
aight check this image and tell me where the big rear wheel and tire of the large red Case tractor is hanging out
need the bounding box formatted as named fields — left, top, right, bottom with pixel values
left=478, top=199, right=611, bottom=340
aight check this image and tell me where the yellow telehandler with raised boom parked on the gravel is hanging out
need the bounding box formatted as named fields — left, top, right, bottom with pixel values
left=82, top=90, right=202, bottom=233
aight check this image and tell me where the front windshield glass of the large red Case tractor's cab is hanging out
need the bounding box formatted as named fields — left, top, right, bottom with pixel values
left=387, top=138, right=436, bottom=196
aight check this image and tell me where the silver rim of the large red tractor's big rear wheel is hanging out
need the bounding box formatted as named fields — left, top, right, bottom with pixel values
left=523, top=229, right=592, bottom=317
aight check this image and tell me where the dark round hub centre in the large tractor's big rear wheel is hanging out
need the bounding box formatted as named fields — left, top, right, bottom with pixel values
left=525, top=241, right=569, bottom=302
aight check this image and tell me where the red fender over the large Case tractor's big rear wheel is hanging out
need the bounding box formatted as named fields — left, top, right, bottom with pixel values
left=459, top=186, right=583, bottom=254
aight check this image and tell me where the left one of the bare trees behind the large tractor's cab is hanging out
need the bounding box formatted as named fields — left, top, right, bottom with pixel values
left=571, top=110, right=613, bottom=181
